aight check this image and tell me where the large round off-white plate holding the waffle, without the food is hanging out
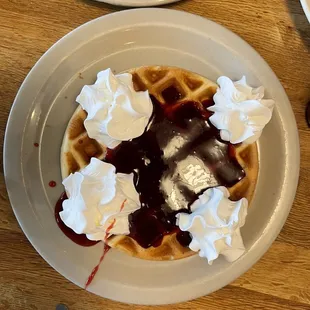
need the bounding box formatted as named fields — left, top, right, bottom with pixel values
left=4, top=9, right=299, bottom=304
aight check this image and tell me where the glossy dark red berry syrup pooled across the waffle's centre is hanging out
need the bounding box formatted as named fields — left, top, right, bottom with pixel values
left=106, top=89, right=245, bottom=248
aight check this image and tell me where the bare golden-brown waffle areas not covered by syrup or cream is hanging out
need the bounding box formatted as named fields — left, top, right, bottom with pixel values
left=61, top=66, right=259, bottom=261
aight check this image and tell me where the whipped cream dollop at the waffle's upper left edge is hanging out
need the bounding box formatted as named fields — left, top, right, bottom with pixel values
left=76, top=69, right=153, bottom=149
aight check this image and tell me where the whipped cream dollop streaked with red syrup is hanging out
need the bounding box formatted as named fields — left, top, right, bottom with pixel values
left=59, top=157, right=140, bottom=240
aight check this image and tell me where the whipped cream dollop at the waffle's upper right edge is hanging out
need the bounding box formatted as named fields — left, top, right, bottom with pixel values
left=208, top=76, right=274, bottom=144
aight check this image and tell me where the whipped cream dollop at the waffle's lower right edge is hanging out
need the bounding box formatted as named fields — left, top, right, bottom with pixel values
left=176, top=186, right=248, bottom=265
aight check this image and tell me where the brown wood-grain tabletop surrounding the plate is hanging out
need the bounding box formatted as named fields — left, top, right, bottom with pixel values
left=0, top=0, right=310, bottom=310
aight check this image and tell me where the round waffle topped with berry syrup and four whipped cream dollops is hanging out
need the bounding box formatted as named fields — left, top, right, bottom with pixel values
left=55, top=66, right=274, bottom=264
